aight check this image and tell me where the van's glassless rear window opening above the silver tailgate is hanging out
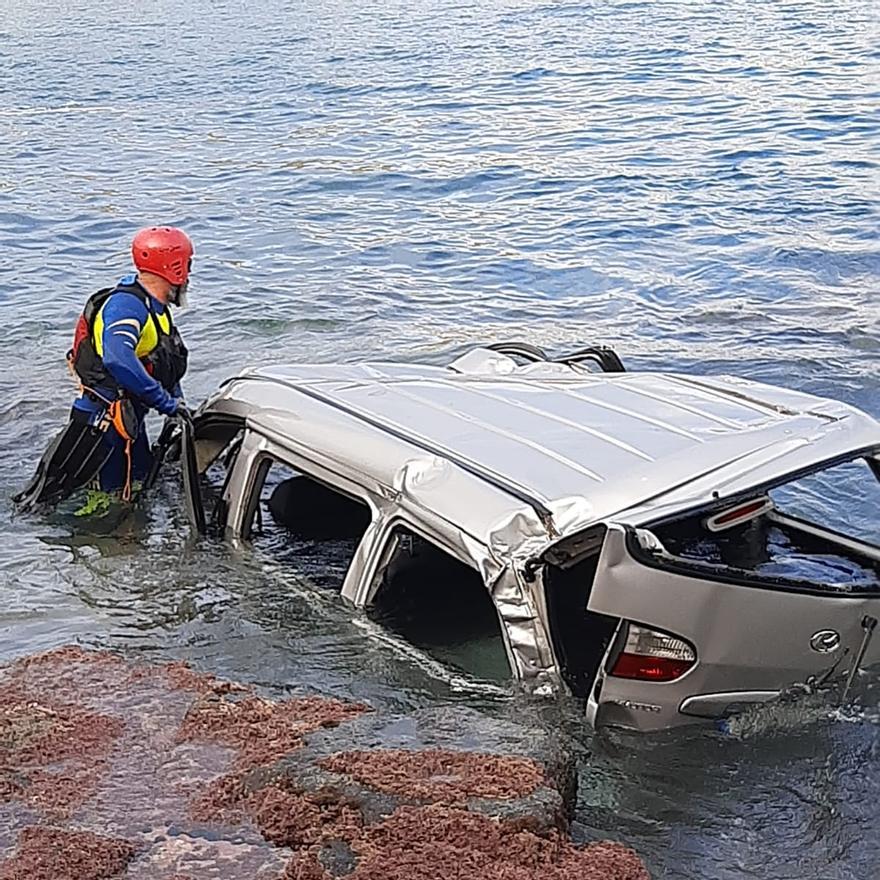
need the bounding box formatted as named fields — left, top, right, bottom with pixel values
left=655, top=459, right=880, bottom=594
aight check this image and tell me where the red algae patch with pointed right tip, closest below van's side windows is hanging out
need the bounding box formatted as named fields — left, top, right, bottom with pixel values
left=178, top=692, right=369, bottom=770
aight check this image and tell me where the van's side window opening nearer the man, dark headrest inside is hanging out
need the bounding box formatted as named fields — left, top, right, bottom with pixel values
left=250, top=458, right=371, bottom=592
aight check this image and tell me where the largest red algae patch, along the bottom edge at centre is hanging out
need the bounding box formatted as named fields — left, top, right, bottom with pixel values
left=196, top=768, right=650, bottom=880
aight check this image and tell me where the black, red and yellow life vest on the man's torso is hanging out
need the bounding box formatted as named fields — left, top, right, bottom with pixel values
left=67, top=283, right=189, bottom=397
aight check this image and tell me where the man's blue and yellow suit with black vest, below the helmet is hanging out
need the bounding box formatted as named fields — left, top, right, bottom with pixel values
left=71, top=274, right=187, bottom=492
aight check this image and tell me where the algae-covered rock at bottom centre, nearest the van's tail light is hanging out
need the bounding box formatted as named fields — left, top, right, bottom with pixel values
left=189, top=696, right=649, bottom=880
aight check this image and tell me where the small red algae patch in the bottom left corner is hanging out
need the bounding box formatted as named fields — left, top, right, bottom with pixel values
left=0, top=827, right=135, bottom=880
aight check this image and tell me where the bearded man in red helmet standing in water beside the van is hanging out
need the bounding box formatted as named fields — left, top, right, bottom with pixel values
left=15, top=226, right=193, bottom=515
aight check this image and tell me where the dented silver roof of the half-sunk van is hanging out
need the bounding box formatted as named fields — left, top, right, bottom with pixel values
left=205, top=349, right=880, bottom=543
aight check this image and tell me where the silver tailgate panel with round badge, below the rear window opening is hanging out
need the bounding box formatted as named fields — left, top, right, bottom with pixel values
left=588, top=525, right=880, bottom=710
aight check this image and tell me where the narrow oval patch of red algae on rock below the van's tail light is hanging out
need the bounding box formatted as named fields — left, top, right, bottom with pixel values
left=320, top=749, right=545, bottom=804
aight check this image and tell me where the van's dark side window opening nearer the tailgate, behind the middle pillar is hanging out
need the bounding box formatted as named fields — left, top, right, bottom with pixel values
left=370, top=528, right=510, bottom=681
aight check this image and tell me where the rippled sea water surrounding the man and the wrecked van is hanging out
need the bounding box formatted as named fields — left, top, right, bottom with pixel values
left=0, top=0, right=880, bottom=880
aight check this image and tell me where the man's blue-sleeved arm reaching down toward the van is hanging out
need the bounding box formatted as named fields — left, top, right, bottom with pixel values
left=101, top=293, right=177, bottom=416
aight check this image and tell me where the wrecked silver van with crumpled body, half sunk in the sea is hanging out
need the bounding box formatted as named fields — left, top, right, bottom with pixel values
left=190, top=344, right=880, bottom=730
